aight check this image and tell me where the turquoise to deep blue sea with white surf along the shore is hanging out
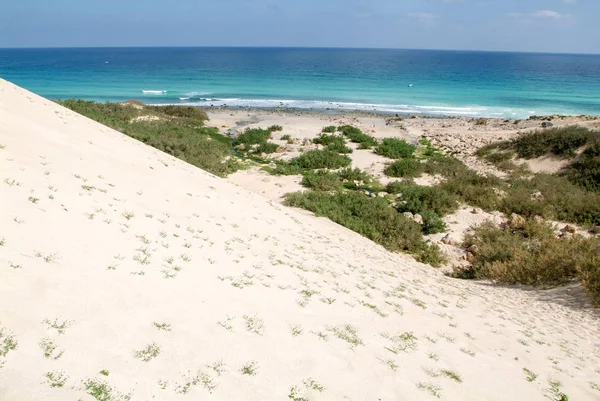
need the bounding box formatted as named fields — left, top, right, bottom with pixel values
left=0, top=48, right=600, bottom=118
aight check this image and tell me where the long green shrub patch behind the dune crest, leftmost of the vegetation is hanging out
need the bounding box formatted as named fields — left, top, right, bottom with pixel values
left=59, top=99, right=240, bottom=177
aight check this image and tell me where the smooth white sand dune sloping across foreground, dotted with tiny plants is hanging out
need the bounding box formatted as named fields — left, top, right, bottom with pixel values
left=0, top=81, right=600, bottom=401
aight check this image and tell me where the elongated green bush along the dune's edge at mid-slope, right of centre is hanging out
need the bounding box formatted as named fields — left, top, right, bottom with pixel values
left=284, top=191, right=442, bottom=265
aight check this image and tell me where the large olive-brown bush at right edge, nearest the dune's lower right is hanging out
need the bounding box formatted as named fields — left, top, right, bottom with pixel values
left=455, top=219, right=600, bottom=305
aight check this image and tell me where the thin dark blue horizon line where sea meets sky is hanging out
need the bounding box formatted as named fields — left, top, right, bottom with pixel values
left=0, top=45, right=600, bottom=56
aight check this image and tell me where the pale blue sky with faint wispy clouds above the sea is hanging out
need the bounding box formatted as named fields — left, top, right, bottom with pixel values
left=0, top=0, right=600, bottom=53
